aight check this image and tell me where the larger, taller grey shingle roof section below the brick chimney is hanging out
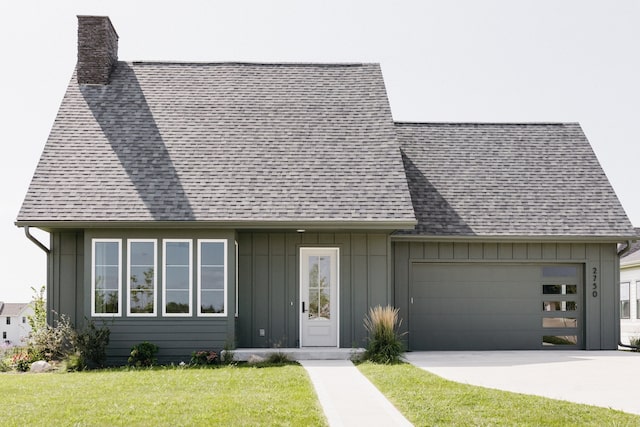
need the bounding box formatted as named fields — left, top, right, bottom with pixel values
left=17, top=62, right=415, bottom=229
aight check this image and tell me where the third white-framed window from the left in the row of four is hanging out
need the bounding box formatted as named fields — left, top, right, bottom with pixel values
left=162, top=239, right=192, bottom=316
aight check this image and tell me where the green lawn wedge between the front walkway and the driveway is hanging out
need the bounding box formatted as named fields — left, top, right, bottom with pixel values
left=358, top=363, right=640, bottom=426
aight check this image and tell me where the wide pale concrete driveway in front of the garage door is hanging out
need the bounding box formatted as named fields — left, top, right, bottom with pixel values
left=406, top=351, right=640, bottom=414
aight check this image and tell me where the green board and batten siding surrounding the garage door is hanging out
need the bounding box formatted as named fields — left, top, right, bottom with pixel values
left=392, top=241, right=620, bottom=350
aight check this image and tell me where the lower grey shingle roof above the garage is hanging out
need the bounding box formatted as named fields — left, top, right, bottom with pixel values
left=396, top=123, right=634, bottom=237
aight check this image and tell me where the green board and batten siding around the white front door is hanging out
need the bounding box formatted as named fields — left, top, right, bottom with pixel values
left=236, top=232, right=393, bottom=348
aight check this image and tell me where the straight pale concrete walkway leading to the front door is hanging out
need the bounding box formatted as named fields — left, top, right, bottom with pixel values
left=299, top=360, right=412, bottom=427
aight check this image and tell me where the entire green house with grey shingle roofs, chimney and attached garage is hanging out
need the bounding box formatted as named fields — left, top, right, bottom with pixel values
left=16, top=16, right=635, bottom=361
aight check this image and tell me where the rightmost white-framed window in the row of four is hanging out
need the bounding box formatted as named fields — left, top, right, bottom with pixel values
left=198, top=240, right=227, bottom=316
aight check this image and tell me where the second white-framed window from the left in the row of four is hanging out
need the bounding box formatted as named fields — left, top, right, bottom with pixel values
left=127, top=239, right=157, bottom=316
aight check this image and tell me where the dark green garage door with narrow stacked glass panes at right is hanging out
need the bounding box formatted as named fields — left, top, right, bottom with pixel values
left=409, top=262, right=584, bottom=350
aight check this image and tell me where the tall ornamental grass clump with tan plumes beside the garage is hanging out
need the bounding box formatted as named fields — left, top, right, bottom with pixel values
left=364, top=305, right=404, bottom=364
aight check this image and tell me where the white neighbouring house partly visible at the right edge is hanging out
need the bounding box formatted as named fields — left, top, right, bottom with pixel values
left=620, top=228, right=640, bottom=344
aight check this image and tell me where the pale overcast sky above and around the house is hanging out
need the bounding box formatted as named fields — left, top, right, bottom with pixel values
left=0, top=0, right=640, bottom=302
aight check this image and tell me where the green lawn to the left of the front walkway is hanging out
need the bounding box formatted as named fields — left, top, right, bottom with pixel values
left=0, top=365, right=326, bottom=426
